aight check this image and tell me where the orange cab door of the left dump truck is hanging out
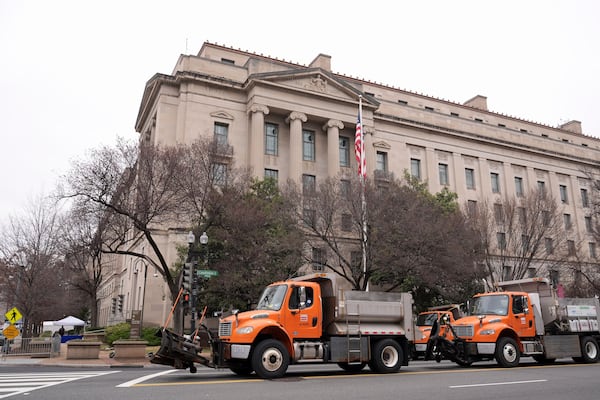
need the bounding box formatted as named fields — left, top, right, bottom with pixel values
left=284, top=284, right=322, bottom=339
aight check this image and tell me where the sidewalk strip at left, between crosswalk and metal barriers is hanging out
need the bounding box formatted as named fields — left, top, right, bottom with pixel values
left=0, top=343, right=160, bottom=368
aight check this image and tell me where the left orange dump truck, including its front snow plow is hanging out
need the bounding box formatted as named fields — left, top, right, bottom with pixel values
left=151, top=273, right=413, bottom=379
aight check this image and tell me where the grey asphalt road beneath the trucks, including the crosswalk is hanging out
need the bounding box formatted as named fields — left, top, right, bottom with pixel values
left=0, top=359, right=600, bottom=400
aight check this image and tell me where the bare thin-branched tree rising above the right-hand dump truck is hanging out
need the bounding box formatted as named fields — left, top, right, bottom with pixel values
left=466, top=190, right=568, bottom=287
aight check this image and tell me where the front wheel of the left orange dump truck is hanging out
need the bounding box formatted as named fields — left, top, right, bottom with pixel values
left=252, top=339, right=290, bottom=379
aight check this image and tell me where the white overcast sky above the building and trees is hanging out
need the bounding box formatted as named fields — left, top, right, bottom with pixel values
left=0, top=0, right=600, bottom=222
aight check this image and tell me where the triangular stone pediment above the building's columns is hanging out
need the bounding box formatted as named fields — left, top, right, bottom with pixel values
left=250, top=68, right=365, bottom=103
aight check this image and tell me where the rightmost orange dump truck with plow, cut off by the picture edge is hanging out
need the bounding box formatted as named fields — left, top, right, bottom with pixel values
left=427, top=278, right=600, bottom=367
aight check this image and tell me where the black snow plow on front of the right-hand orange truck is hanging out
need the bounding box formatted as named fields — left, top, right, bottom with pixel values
left=425, top=321, right=473, bottom=367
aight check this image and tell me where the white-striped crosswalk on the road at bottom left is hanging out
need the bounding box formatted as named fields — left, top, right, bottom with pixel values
left=0, top=371, right=118, bottom=399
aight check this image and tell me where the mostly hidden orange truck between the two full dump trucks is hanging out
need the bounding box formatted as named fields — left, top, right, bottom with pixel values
left=411, top=304, right=462, bottom=360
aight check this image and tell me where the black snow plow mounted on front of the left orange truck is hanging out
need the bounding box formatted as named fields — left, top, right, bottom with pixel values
left=150, top=329, right=215, bottom=373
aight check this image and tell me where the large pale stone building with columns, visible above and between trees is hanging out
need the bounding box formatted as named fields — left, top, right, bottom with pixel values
left=99, top=42, right=600, bottom=325
